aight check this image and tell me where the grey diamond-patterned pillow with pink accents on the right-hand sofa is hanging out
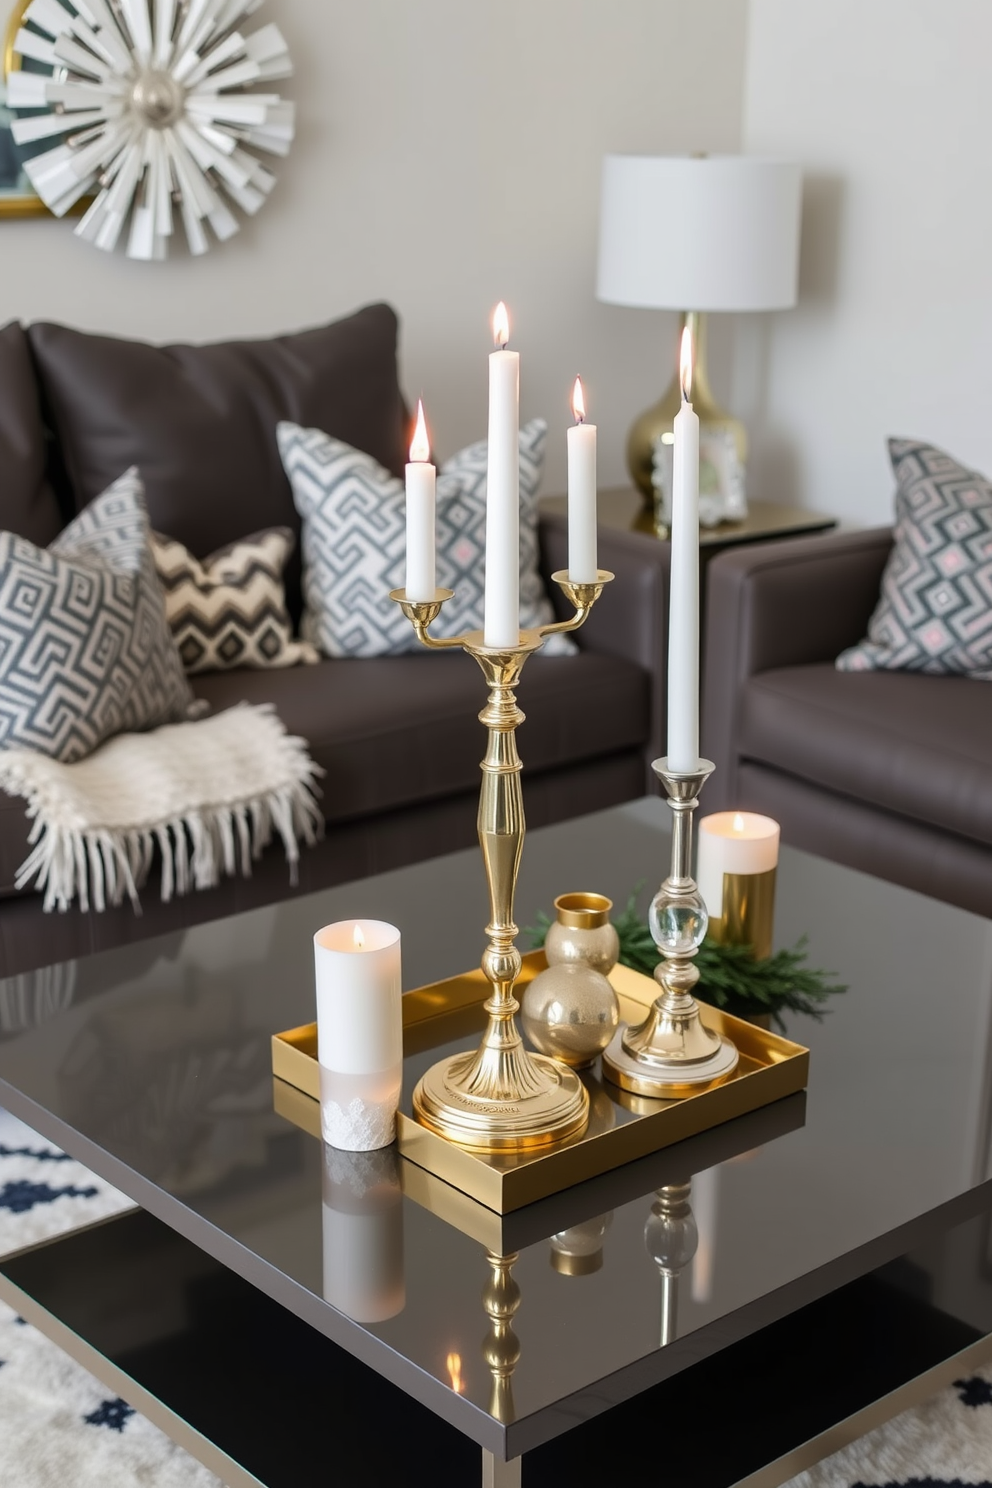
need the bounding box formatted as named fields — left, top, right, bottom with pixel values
left=837, top=439, right=992, bottom=682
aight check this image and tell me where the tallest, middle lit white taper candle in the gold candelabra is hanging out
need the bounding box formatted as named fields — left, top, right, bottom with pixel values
left=483, top=301, right=521, bottom=647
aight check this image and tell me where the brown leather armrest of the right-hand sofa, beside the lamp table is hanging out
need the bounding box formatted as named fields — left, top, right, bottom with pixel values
left=702, top=527, right=892, bottom=811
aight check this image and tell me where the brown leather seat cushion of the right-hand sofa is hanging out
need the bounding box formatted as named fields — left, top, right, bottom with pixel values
left=739, top=662, right=992, bottom=844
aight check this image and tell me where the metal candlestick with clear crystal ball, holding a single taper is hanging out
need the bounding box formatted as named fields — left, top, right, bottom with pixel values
left=602, top=759, right=739, bottom=1100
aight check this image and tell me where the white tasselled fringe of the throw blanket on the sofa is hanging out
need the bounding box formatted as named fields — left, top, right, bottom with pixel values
left=4, top=717, right=324, bottom=914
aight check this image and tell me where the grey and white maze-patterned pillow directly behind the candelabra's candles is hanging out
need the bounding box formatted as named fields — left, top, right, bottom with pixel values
left=278, top=418, right=576, bottom=656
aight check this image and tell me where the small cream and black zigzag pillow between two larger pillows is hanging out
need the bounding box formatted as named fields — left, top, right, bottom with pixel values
left=152, top=527, right=320, bottom=674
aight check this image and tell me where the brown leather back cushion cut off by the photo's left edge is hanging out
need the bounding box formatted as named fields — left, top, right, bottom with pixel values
left=0, top=321, right=63, bottom=548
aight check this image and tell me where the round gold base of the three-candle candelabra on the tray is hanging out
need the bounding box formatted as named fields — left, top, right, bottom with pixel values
left=413, top=1051, right=589, bottom=1152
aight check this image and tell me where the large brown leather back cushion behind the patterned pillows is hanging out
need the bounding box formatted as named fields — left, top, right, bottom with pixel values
left=28, top=305, right=406, bottom=613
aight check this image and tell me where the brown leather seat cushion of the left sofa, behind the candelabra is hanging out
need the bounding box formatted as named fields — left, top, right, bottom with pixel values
left=193, top=652, right=648, bottom=823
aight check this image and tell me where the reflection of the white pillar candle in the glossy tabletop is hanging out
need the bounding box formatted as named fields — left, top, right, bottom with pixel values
left=323, top=1146, right=406, bottom=1323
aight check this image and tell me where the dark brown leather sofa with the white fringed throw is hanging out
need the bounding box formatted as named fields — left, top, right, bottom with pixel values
left=0, top=305, right=668, bottom=975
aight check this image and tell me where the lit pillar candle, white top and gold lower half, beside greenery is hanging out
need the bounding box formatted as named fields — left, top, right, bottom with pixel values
left=696, top=811, right=779, bottom=961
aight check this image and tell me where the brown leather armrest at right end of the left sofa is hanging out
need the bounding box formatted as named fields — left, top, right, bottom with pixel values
left=538, top=512, right=671, bottom=767
